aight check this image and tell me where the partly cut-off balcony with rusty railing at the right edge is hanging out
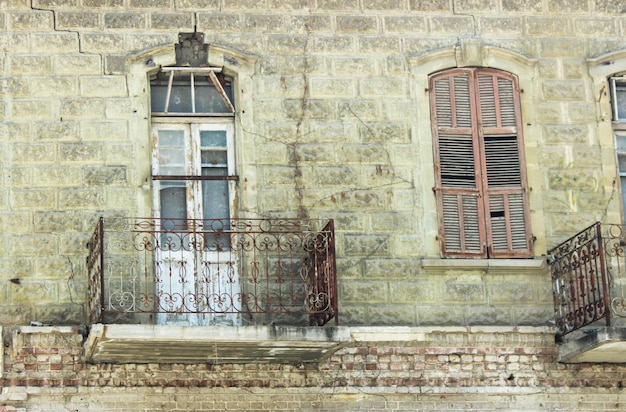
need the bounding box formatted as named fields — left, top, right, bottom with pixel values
left=548, top=223, right=626, bottom=363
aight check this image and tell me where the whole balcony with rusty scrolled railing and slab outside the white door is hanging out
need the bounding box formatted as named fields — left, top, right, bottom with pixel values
left=87, top=218, right=338, bottom=361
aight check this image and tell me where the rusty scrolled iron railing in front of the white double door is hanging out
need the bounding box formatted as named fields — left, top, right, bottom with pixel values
left=87, top=218, right=338, bottom=326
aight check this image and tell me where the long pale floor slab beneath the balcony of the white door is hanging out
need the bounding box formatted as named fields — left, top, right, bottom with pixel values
left=85, top=324, right=350, bottom=364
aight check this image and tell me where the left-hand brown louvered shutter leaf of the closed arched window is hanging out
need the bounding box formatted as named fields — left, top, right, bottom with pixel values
left=430, top=70, right=487, bottom=257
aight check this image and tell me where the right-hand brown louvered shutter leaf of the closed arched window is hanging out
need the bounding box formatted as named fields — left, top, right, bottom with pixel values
left=476, top=69, right=532, bottom=258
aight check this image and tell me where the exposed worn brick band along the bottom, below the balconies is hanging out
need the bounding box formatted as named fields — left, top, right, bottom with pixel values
left=0, top=327, right=626, bottom=412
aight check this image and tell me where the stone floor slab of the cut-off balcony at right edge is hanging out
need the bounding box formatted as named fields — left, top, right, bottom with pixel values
left=559, top=327, right=626, bottom=363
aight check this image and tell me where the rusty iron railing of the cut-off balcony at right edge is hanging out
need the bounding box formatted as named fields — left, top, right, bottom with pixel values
left=548, top=222, right=608, bottom=336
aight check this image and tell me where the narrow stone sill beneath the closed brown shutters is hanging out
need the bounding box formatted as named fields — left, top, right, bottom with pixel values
left=422, top=257, right=548, bottom=275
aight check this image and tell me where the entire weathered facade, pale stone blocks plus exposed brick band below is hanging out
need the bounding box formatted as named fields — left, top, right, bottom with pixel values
left=0, top=0, right=626, bottom=411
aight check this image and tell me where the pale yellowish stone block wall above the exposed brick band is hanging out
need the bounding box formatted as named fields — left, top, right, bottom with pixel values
left=0, top=0, right=626, bottom=325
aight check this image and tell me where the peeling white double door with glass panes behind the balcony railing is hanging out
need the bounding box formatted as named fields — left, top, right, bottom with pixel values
left=152, top=123, right=241, bottom=326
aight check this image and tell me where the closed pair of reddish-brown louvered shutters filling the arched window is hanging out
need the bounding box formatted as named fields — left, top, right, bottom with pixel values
left=429, top=68, right=532, bottom=258
